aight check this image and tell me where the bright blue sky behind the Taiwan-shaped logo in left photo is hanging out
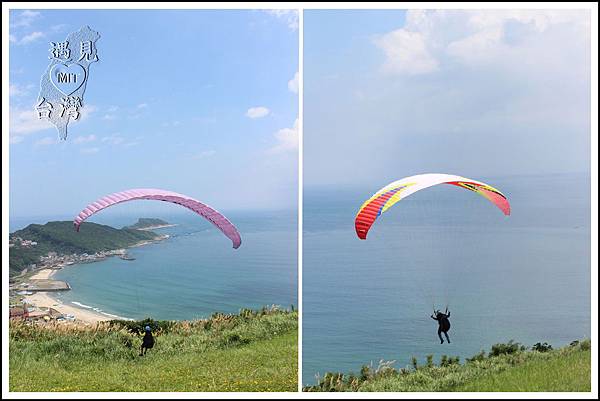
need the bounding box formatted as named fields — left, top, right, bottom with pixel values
left=5, top=10, right=298, bottom=217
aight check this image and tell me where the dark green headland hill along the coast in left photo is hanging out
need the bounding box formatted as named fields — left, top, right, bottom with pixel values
left=9, top=221, right=157, bottom=276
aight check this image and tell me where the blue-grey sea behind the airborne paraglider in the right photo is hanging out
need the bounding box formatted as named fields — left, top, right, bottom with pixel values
left=302, top=174, right=591, bottom=384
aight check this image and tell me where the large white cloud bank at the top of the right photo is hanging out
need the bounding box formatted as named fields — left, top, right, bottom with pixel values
left=374, top=10, right=589, bottom=75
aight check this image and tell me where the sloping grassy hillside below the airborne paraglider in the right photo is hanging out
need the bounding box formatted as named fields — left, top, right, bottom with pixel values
left=304, top=340, right=591, bottom=392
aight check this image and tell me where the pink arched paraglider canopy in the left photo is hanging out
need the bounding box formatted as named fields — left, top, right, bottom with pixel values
left=73, top=188, right=242, bottom=249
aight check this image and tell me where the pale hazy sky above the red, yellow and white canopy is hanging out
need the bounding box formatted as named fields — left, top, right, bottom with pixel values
left=303, top=10, right=591, bottom=189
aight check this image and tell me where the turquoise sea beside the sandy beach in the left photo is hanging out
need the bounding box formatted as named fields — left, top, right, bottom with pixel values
left=47, top=211, right=298, bottom=320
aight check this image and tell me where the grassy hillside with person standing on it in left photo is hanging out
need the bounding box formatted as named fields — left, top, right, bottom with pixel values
left=9, top=309, right=298, bottom=391
